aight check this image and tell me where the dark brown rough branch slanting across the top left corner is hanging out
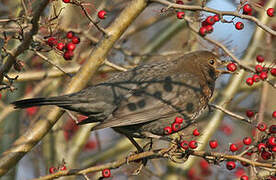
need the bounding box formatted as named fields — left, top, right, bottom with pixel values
left=0, top=0, right=50, bottom=83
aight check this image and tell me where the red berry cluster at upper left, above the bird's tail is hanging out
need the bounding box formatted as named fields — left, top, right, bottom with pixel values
left=47, top=31, right=80, bottom=60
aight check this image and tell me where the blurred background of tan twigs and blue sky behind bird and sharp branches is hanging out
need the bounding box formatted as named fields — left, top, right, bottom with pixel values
left=0, top=0, right=276, bottom=180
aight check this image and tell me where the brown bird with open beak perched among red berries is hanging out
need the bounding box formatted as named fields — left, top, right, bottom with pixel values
left=12, top=51, right=225, bottom=148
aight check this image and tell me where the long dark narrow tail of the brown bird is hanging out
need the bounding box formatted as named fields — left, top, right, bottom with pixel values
left=11, top=97, right=68, bottom=109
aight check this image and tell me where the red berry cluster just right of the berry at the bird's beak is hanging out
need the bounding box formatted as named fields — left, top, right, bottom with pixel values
left=246, top=55, right=276, bottom=86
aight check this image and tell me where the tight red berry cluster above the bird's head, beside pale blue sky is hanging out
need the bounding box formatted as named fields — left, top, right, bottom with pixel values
left=199, top=14, right=220, bottom=36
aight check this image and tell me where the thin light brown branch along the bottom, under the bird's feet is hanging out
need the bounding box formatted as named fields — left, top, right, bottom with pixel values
left=33, top=145, right=276, bottom=180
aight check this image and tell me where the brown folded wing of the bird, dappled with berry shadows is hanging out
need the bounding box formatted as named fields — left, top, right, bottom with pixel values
left=93, top=73, right=202, bottom=129
